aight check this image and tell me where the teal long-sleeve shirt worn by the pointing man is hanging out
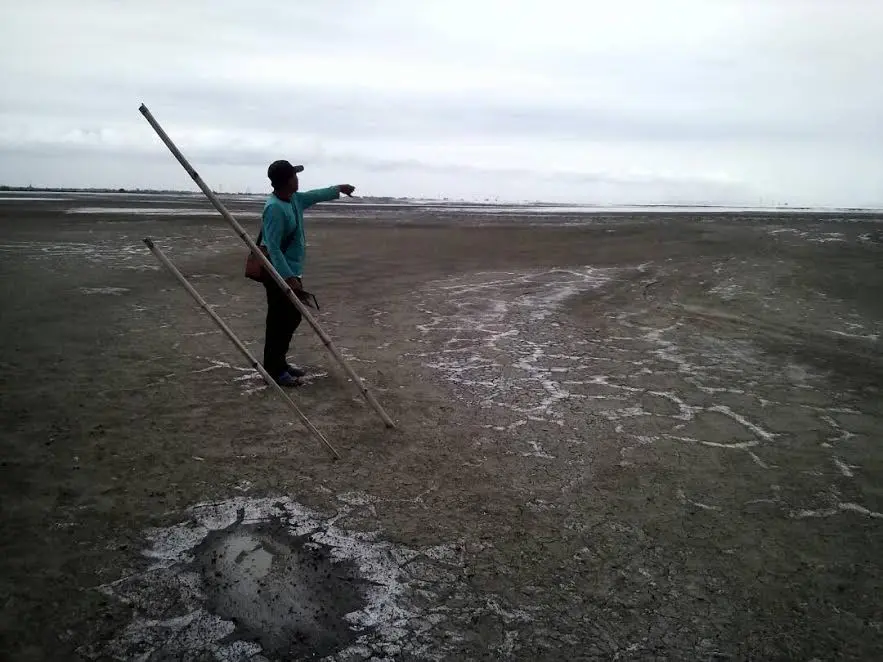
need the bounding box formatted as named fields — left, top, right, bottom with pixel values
left=261, top=186, right=340, bottom=278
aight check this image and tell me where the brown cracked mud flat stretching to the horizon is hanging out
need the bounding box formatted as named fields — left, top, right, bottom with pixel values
left=0, top=198, right=883, bottom=660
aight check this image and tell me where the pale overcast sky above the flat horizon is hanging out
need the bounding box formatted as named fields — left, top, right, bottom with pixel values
left=0, top=0, right=883, bottom=206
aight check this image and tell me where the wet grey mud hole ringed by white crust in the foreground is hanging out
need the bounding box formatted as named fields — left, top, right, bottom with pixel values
left=78, top=495, right=482, bottom=662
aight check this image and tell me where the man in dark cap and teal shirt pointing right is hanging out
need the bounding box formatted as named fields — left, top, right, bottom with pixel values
left=260, top=161, right=355, bottom=386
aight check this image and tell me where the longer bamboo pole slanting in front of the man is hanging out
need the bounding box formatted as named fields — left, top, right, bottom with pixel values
left=138, top=103, right=395, bottom=428
